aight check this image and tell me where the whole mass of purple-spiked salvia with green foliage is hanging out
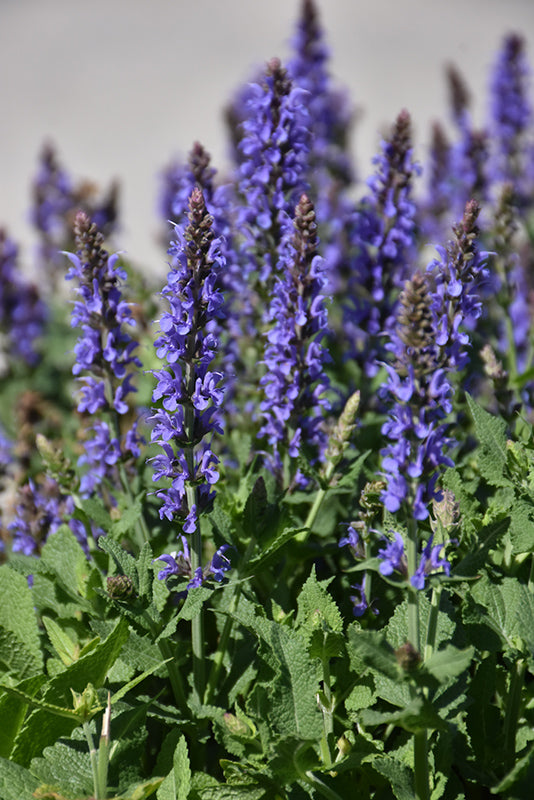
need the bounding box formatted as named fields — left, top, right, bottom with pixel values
left=0, top=0, right=534, bottom=800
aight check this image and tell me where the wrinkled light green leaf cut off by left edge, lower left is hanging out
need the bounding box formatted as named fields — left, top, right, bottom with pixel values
left=0, top=565, right=43, bottom=680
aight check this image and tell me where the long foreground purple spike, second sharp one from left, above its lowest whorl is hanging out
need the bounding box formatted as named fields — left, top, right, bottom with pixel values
left=152, top=187, right=225, bottom=533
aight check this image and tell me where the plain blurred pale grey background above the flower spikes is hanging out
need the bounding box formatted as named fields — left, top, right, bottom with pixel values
left=0, top=0, right=534, bottom=273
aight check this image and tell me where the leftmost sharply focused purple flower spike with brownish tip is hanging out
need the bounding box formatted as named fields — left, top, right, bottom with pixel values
left=66, top=212, right=142, bottom=495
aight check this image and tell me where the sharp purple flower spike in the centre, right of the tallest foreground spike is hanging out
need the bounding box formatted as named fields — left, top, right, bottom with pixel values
left=258, top=194, right=329, bottom=478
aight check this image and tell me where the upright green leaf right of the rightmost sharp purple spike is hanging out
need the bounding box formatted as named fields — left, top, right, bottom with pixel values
left=472, top=394, right=511, bottom=486
